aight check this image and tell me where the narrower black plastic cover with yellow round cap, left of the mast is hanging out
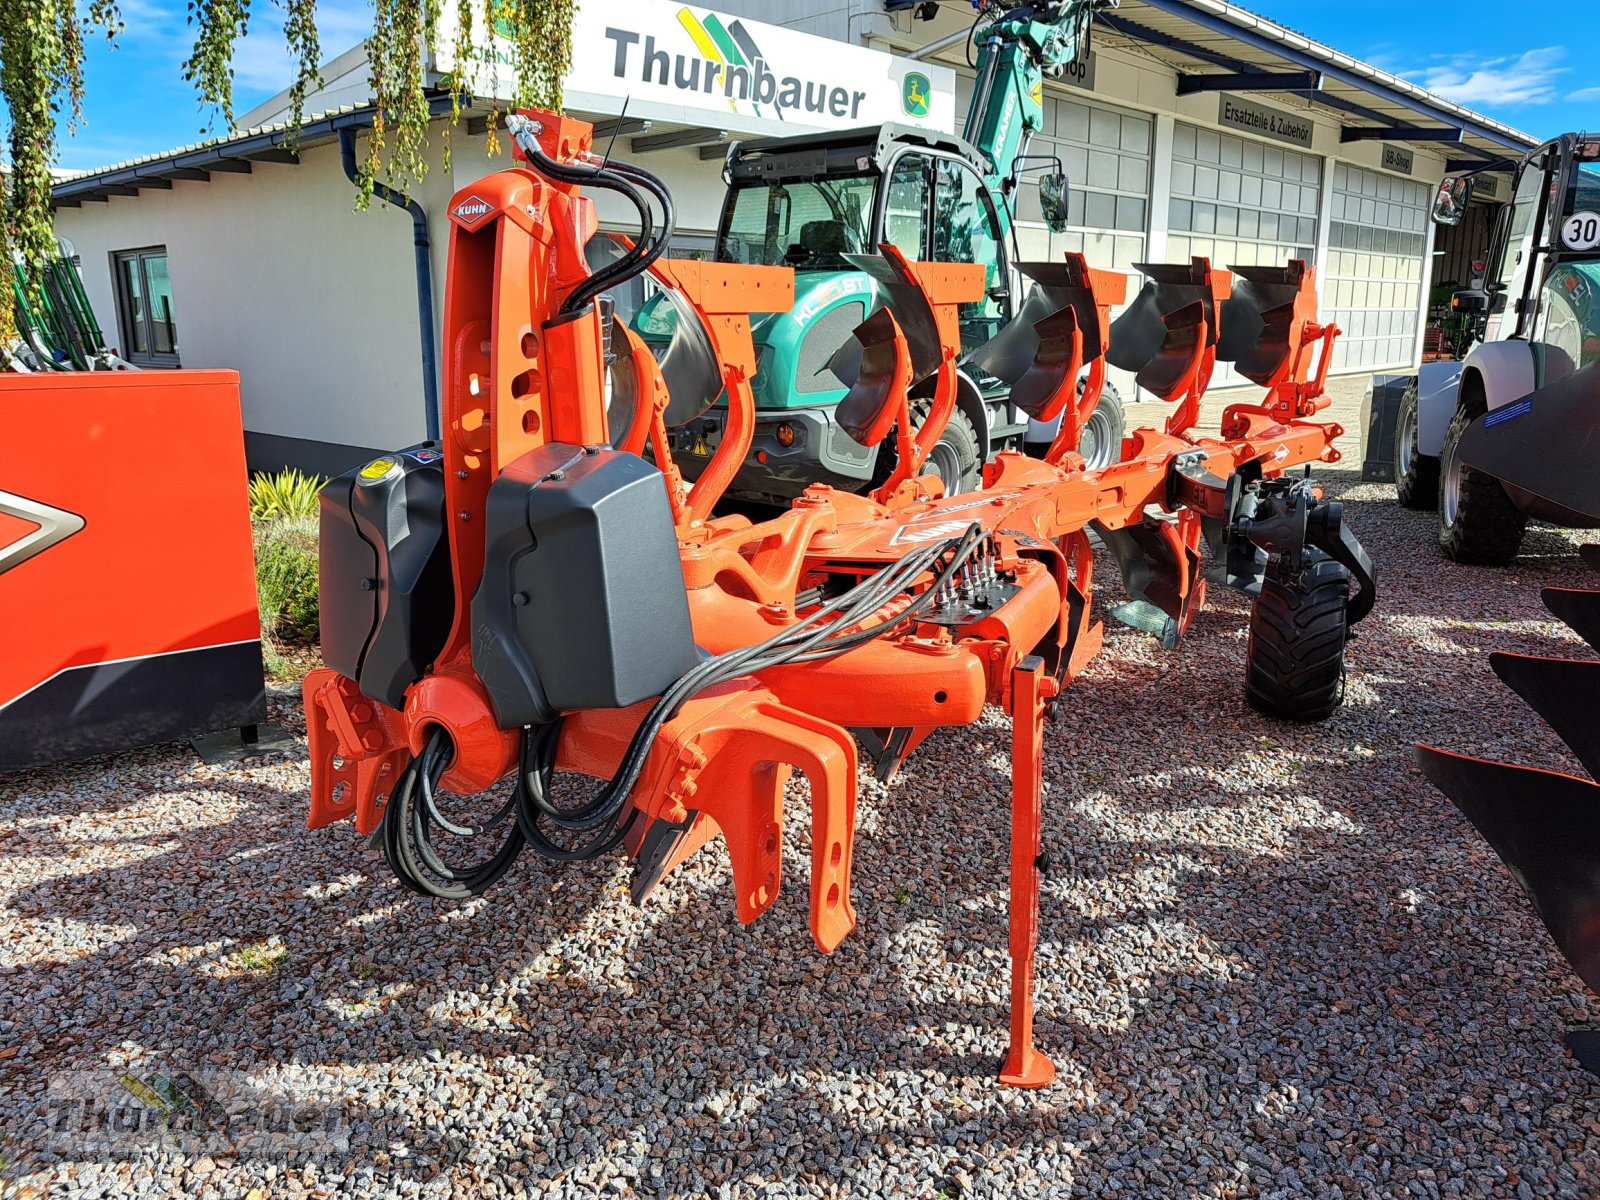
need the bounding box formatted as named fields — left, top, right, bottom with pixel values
left=318, top=442, right=456, bottom=709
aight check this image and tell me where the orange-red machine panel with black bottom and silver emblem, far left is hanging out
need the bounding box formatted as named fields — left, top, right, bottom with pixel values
left=0, top=371, right=266, bottom=770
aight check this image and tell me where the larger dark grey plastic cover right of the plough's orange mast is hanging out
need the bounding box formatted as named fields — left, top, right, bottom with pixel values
left=472, top=443, right=699, bottom=730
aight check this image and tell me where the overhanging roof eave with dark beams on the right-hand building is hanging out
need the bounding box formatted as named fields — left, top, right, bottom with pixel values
left=1096, top=0, right=1541, bottom=170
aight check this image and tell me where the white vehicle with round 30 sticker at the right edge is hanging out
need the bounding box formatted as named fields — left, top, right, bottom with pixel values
left=1394, top=133, right=1600, bottom=565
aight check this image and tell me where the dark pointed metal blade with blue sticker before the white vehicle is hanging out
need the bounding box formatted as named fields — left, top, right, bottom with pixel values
left=1456, top=363, right=1600, bottom=528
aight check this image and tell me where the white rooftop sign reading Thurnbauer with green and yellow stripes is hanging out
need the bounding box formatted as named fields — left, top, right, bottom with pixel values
left=432, top=0, right=955, bottom=136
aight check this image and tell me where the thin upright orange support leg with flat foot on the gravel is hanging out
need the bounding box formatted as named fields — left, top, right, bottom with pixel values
left=1000, top=654, right=1056, bottom=1088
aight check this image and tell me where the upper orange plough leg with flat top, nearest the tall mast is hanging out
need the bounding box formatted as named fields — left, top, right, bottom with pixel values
left=654, top=259, right=795, bottom=525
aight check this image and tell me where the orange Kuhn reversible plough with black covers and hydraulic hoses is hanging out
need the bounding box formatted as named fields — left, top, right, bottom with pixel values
left=306, top=112, right=1373, bottom=1086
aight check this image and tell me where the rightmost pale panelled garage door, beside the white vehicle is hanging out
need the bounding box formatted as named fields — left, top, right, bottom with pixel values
left=1323, top=163, right=1429, bottom=370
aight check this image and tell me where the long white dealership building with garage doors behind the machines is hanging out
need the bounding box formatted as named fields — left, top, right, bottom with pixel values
left=54, top=0, right=1534, bottom=472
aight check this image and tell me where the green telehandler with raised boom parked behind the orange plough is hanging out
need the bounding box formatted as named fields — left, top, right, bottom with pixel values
left=634, top=0, right=1122, bottom=506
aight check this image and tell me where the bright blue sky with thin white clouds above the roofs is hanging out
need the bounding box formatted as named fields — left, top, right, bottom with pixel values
left=37, top=0, right=1600, bottom=168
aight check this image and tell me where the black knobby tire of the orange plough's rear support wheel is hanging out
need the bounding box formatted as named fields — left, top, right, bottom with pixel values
left=1245, top=547, right=1350, bottom=722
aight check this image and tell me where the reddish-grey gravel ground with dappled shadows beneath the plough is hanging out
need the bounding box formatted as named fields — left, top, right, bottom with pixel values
left=0, top=474, right=1600, bottom=1197
